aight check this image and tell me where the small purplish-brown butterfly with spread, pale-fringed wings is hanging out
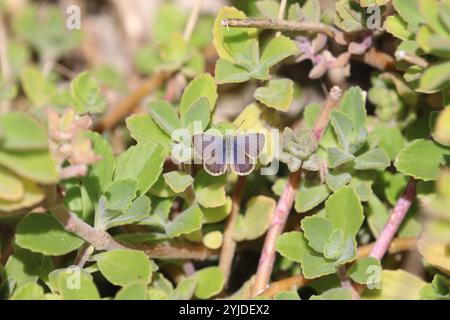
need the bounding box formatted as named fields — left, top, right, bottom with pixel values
left=193, top=133, right=265, bottom=176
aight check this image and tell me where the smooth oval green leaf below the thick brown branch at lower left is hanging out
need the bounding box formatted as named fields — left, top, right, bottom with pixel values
left=95, top=249, right=152, bottom=286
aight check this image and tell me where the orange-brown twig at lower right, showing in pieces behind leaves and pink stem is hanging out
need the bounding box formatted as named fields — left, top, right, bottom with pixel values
left=260, top=238, right=417, bottom=298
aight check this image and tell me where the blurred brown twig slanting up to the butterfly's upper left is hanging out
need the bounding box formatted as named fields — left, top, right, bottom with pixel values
left=95, top=71, right=172, bottom=132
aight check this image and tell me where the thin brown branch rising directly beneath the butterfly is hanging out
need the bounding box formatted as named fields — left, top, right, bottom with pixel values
left=219, top=176, right=246, bottom=287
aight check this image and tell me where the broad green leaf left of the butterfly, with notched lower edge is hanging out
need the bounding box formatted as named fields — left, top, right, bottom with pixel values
left=114, top=143, right=165, bottom=195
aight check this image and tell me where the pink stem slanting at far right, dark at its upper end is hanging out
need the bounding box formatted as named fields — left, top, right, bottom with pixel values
left=369, top=178, right=417, bottom=260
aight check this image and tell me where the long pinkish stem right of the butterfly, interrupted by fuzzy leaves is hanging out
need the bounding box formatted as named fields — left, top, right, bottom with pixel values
left=252, top=87, right=342, bottom=297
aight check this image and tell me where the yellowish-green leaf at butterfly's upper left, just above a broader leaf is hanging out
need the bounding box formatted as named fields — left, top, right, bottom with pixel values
left=126, top=114, right=171, bottom=153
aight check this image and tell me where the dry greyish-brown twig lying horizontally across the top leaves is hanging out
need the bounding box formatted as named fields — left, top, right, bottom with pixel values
left=222, top=18, right=335, bottom=37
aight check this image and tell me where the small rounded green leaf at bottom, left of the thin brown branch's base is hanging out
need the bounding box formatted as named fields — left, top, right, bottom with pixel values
left=194, top=267, right=225, bottom=299
